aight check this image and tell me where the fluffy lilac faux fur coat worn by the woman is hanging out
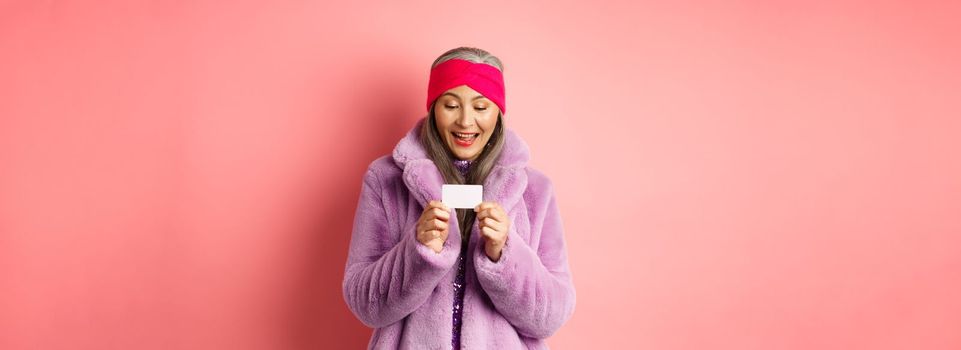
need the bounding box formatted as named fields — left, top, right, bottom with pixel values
left=343, top=118, right=575, bottom=349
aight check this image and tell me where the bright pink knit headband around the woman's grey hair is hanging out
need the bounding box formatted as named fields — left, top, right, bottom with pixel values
left=427, top=58, right=507, bottom=114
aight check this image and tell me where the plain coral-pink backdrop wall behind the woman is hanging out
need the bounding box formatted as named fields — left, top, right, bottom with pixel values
left=0, top=1, right=961, bottom=349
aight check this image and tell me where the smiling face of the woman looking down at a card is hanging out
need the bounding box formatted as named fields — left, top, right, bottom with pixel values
left=434, top=85, right=500, bottom=160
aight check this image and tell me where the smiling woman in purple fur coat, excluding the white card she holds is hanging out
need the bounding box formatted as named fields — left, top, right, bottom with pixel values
left=343, top=47, right=575, bottom=349
